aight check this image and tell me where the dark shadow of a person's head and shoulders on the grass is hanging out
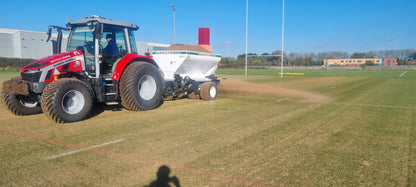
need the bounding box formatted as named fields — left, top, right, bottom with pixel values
left=144, top=165, right=181, bottom=187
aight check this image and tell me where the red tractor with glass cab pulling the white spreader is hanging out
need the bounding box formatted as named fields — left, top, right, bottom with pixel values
left=1, top=16, right=167, bottom=123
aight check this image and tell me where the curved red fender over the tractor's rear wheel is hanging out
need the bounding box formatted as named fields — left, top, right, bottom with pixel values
left=111, top=53, right=159, bottom=80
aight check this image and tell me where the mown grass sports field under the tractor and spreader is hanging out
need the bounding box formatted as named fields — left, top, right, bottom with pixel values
left=0, top=69, right=416, bottom=186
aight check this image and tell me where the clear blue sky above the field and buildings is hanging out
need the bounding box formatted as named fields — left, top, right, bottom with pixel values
left=0, top=0, right=416, bottom=57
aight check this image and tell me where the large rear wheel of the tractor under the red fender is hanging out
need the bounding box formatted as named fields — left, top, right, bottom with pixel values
left=120, top=62, right=163, bottom=111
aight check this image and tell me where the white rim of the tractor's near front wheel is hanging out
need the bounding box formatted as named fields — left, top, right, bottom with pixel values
left=62, top=90, right=85, bottom=114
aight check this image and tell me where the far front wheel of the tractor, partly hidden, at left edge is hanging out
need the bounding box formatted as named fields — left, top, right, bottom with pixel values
left=0, top=91, right=42, bottom=116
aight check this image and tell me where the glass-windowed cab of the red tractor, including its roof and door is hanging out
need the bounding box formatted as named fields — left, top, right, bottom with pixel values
left=67, top=16, right=139, bottom=77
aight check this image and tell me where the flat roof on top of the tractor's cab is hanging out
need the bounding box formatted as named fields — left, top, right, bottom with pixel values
left=67, top=15, right=139, bottom=30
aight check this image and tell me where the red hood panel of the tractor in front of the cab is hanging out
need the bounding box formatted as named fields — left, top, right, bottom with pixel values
left=20, top=50, right=83, bottom=73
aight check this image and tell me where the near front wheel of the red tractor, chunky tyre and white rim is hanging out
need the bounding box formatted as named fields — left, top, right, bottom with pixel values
left=41, top=78, right=93, bottom=123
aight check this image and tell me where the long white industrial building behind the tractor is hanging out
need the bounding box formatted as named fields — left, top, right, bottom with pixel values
left=0, top=28, right=169, bottom=59
